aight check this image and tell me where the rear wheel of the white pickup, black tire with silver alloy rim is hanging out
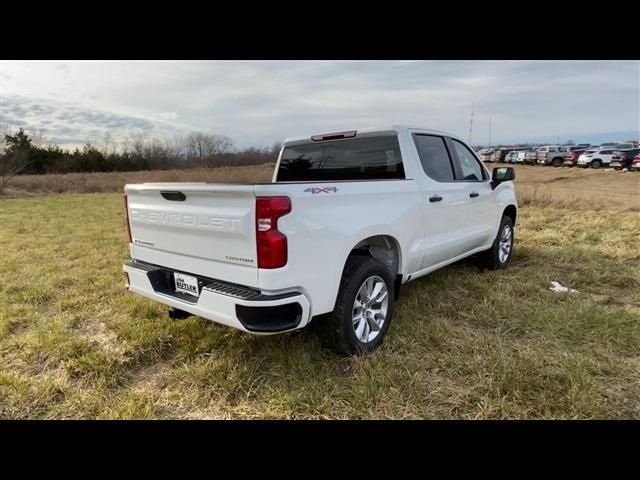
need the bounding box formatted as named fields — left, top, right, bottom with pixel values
left=316, top=255, right=394, bottom=355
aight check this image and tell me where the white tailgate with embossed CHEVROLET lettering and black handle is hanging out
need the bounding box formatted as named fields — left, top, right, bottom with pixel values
left=125, top=183, right=258, bottom=286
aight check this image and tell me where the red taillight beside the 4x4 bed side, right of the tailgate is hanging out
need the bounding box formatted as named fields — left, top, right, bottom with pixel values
left=256, top=197, right=291, bottom=268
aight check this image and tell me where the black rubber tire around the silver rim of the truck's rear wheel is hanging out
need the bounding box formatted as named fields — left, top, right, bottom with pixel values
left=316, top=255, right=394, bottom=355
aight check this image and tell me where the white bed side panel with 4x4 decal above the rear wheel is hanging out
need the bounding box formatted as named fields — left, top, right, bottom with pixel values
left=254, top=180, right=424, bottom=315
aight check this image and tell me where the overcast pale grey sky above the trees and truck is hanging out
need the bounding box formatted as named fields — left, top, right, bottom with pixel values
left=0, top=61, right=640, bottom=147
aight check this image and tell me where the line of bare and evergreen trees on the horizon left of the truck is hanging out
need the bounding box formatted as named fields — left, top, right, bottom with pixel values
left=0, top=127, right=281, bottom=192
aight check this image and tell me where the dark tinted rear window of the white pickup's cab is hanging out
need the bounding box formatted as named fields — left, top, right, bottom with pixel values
left=276, top=135, right=405, bottom=182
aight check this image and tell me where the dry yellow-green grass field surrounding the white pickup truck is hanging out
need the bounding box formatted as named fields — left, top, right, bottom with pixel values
left=0, top=166, right=640, bottom=419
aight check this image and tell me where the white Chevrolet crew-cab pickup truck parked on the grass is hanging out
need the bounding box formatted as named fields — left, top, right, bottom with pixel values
left=124, top=126, right=517, bottom=354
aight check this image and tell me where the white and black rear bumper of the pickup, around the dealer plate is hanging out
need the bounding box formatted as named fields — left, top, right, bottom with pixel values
left=123, top=260, right=311, bottom=334
